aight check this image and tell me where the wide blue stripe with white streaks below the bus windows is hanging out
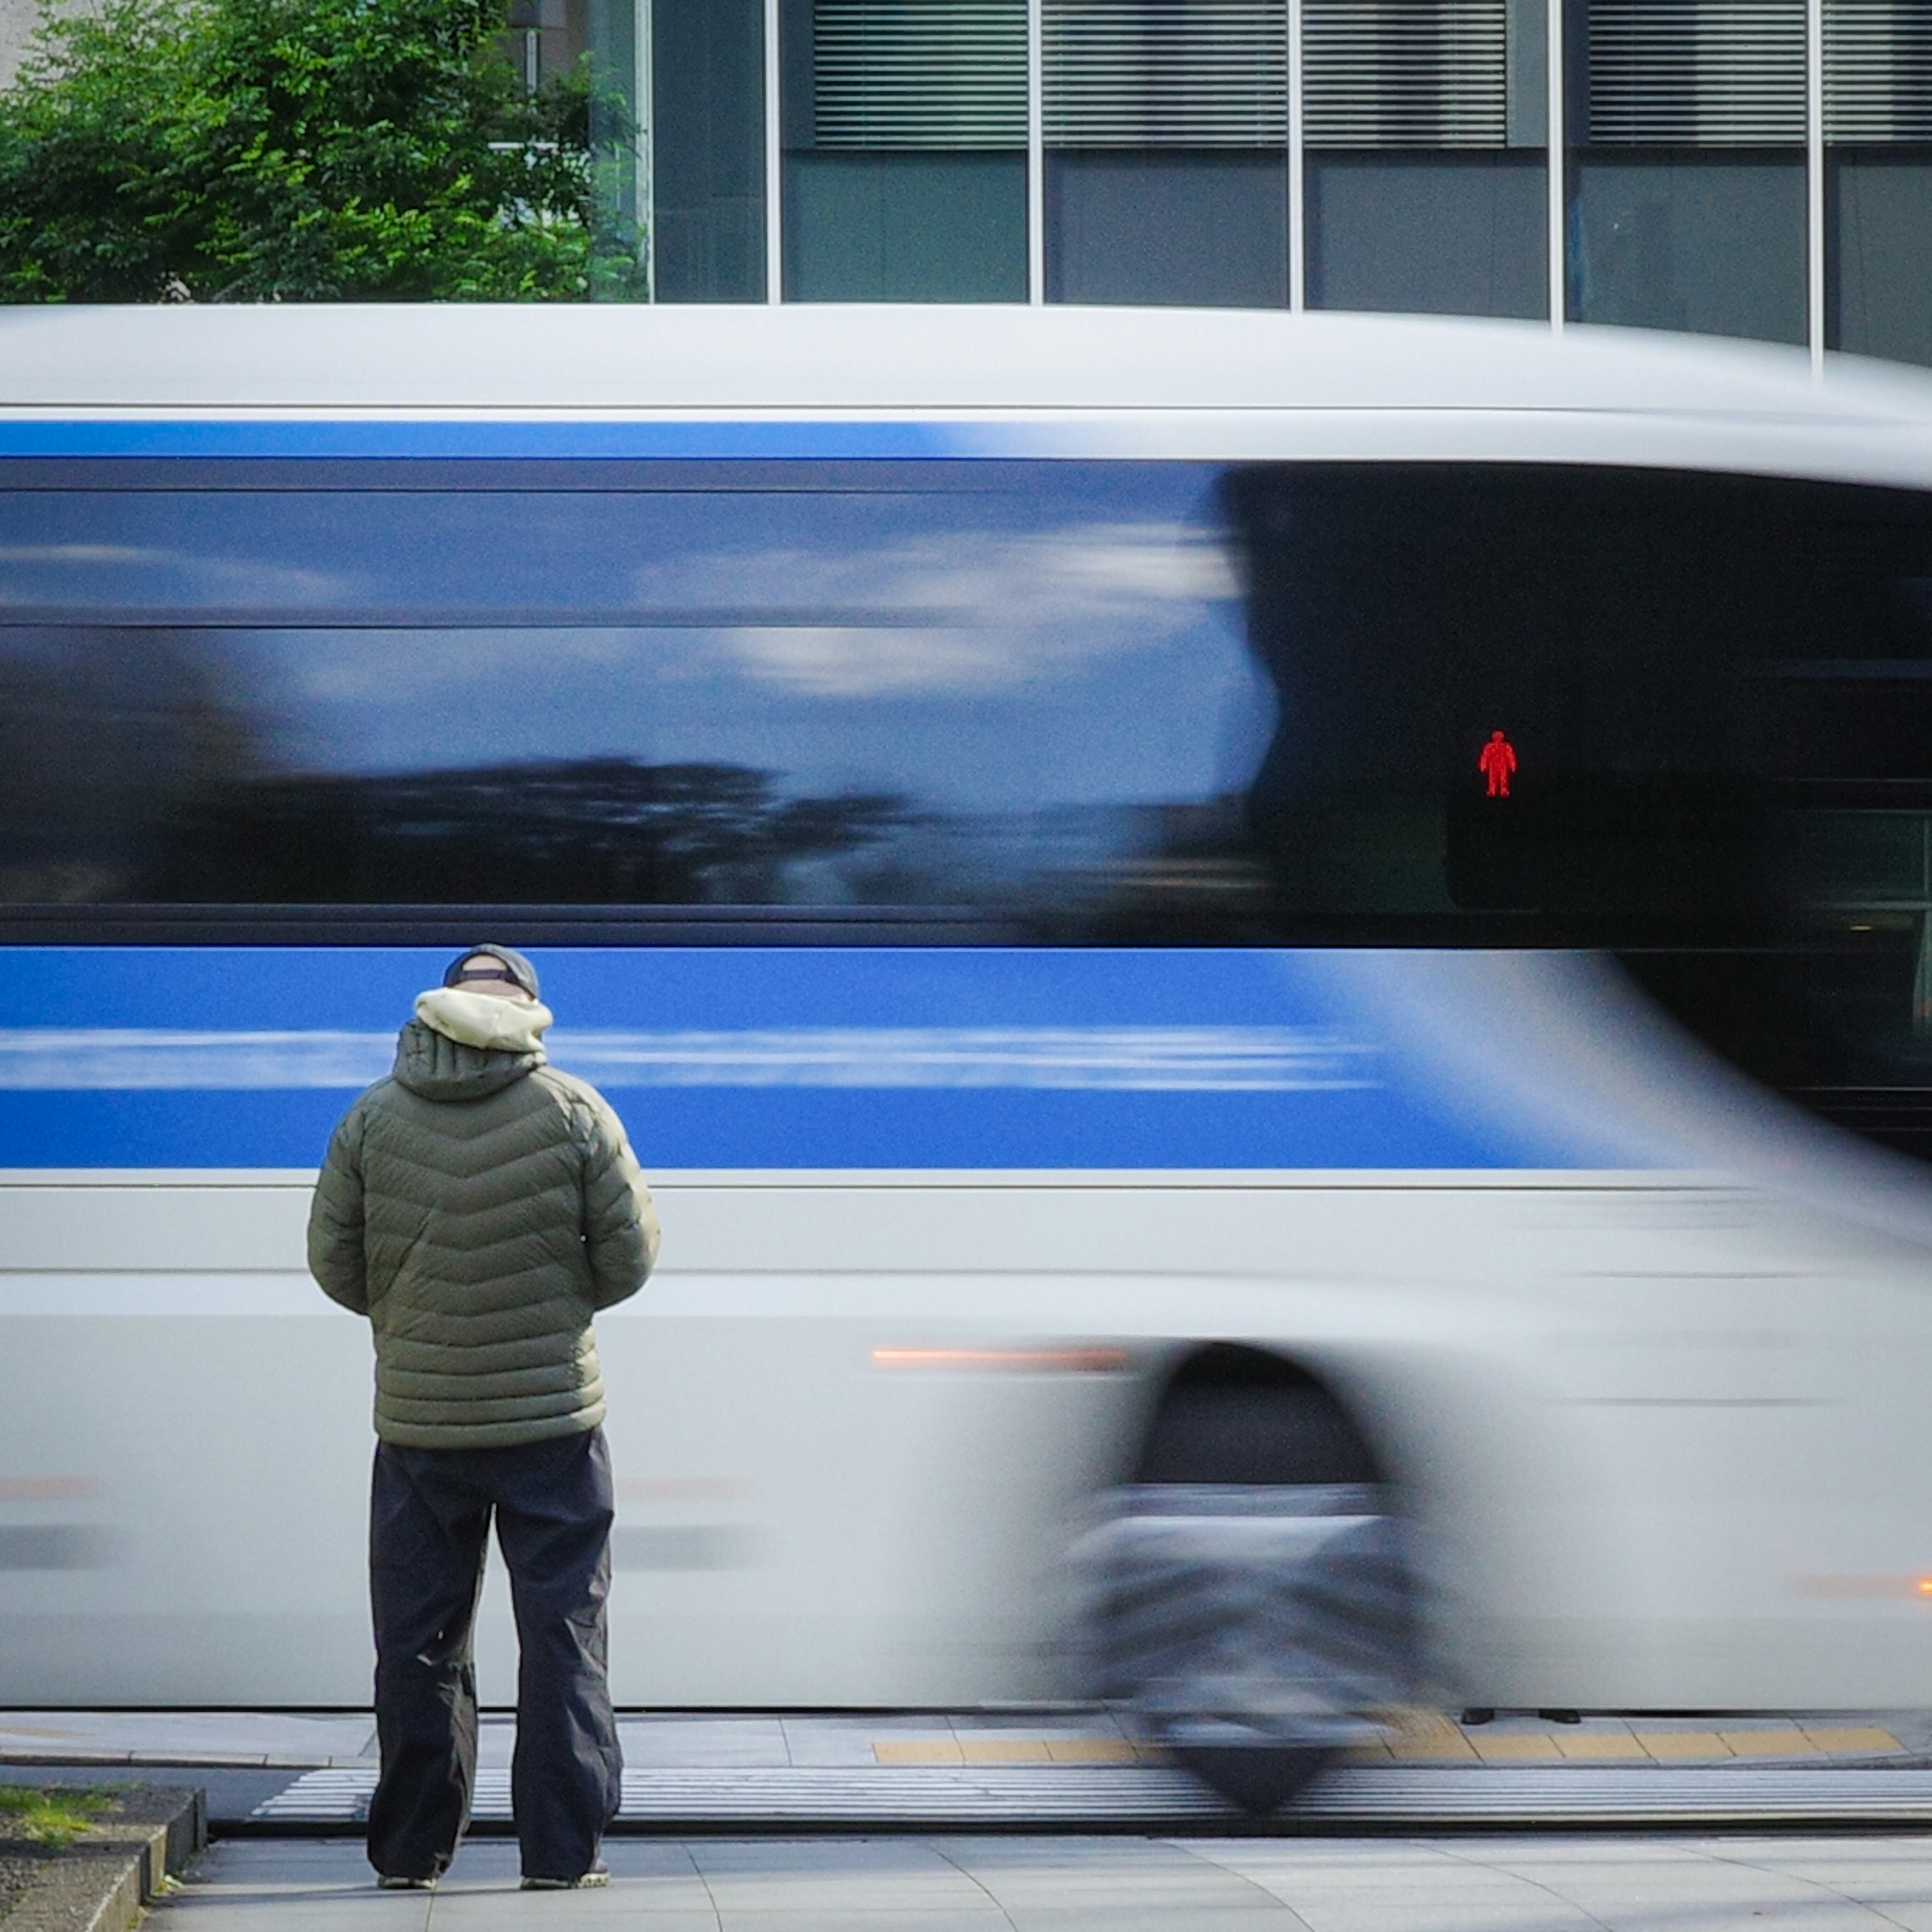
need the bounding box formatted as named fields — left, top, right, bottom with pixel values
left=0, top=947, right=1605, bottom=1169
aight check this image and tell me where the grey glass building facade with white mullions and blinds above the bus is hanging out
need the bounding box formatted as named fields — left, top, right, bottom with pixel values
left=606, top=0, right=1932, bottom=361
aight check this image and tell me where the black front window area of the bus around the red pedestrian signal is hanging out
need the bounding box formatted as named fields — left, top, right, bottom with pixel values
left=1227, top=465, right=1932, bottom=1153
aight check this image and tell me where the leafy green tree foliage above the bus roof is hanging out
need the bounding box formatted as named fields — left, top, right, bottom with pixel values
left=0, top=0, right=639, bottom=301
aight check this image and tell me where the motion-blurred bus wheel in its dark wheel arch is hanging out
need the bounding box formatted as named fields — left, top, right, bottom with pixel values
left=1088, top=1346, right=1410, bottom=1814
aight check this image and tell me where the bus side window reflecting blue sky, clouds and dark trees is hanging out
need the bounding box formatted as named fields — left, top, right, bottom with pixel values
left=0, top=465, right=1273, bottom=935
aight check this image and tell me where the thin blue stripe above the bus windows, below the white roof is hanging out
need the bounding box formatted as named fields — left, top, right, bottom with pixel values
left=0, top=417, right=1012, bottom=460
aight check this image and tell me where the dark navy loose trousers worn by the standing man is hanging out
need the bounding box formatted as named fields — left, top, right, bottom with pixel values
left=369, top=1430, right=624, bottom=1878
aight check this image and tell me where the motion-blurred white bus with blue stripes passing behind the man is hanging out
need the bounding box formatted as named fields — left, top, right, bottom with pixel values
left=0, top=307, right=1932, bottom=1793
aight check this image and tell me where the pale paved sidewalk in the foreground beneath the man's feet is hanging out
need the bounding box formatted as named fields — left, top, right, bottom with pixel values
left=151, top=1833, right=1932, bottom=1932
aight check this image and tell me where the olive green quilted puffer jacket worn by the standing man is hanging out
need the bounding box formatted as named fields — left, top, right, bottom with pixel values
left=309, top=995, right=659, bottom=1449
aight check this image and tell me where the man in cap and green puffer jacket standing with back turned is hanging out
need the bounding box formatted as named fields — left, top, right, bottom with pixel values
left=309, top=947, right=659, bottom=1890
